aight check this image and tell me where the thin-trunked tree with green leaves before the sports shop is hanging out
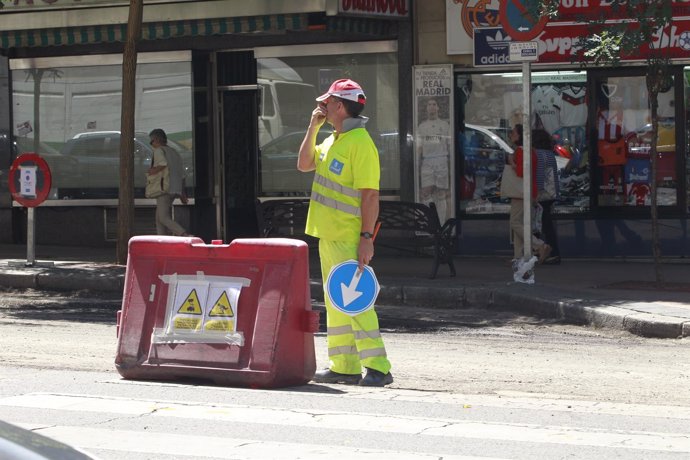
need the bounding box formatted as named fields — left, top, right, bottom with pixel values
left=530, top=0, right=674, bottom=284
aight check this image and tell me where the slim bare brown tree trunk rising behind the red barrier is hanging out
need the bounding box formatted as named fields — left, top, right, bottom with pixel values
left=116, top=0, right=144, bottom=265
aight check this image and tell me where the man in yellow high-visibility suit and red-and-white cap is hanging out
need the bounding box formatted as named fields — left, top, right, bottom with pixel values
left=297, top=79, right=393, bottom=386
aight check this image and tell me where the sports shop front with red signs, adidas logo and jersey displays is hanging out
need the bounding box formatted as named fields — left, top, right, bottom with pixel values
left=415, top=0, right=690, bottom=257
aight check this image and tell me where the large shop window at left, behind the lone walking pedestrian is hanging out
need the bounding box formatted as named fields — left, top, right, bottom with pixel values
left=10, top=52, right=194, bottom=200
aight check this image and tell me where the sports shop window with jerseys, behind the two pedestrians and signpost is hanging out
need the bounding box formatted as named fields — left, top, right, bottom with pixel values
left=456, top=71, right=590, bottom=214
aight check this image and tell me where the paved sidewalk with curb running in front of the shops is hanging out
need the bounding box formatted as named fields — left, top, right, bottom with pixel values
left=0, top=241, right=690, bottom=338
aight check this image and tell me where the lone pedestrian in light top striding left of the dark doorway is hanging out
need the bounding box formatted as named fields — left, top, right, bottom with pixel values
left=148, top=128, right=191, bottom=236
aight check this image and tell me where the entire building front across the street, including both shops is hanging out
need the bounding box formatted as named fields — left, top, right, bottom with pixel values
left=0, top=0, right=690, bottom=257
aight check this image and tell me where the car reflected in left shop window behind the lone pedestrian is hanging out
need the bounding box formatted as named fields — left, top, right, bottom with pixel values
left=59, top=131, right=194, bottom=198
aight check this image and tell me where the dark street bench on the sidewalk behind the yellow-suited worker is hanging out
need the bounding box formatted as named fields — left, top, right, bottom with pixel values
left=256, top=198, right=456, bottom=278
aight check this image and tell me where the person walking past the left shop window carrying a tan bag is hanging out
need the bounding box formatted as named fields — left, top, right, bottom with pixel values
left=146, top=128, right=191, bottom=236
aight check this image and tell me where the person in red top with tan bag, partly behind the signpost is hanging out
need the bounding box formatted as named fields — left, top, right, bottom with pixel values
left=501, top=124, right=551, bottom=266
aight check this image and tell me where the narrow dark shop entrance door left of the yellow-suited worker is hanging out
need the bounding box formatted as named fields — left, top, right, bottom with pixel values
left=216, top=51, right=258, bottom=242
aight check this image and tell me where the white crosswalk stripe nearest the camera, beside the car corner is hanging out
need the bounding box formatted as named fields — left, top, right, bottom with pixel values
left=18, top=423, right=501, bottom=460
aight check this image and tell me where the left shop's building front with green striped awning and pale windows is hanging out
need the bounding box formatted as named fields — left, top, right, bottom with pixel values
left=0, top=0, right=412, bottom=246
